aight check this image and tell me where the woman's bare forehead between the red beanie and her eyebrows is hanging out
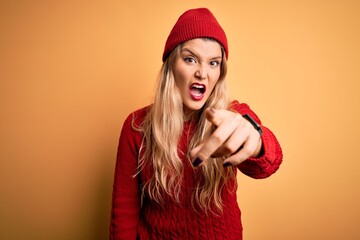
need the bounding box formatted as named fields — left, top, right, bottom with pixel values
left=181, top=38, right=222, bottom=58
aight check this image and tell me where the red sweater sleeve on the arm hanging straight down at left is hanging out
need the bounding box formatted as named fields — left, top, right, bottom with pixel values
left=109, top=114, right=141, bottom=240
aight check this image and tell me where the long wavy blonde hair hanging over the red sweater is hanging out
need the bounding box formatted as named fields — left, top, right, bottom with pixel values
left=138, top=39, right=235, bottom=212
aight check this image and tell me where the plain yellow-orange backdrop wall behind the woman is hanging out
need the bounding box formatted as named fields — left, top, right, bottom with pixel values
left=0, top=0, right=360, bottom=240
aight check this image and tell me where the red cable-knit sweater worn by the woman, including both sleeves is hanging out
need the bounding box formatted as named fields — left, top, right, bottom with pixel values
left=110, top=101, right=282, bottom=240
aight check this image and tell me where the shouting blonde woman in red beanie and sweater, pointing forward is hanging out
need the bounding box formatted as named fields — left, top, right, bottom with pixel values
left=110, top=8, right=282, bottom=240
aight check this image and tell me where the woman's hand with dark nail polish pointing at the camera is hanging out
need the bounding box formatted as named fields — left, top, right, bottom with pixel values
left=190, top=108, right=262, bottom=166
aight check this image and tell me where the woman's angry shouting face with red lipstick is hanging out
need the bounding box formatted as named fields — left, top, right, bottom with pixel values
left=174, top=38, right=222, bottom=113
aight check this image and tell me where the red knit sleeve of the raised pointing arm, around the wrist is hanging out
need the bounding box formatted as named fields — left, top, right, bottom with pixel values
left=230, top=101, right=283, bottom=179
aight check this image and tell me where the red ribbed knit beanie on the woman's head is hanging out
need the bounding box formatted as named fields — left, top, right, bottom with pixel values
left=162, top=8, right=229, bottom=62
